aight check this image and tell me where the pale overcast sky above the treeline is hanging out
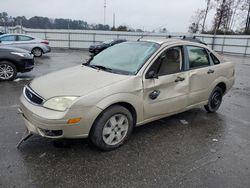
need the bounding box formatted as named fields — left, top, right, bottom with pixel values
left=0, top=0, right=212, bottom=32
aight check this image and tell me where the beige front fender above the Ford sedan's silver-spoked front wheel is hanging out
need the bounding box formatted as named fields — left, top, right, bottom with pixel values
left=72, top=76, right=143, bottom=122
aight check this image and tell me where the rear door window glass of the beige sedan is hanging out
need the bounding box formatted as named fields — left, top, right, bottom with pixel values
left=187, top=46, right=210, bottom=69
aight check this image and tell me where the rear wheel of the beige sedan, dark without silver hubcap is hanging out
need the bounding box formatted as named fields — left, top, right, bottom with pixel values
left=204, top=86, right=223, bottom=113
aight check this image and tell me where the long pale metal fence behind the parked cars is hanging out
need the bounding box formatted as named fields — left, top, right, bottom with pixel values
left=5, top=26, right=250, bottom=55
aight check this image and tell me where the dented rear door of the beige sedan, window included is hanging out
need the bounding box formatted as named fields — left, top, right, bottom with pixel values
left=186, top=46, right=215, bottom=106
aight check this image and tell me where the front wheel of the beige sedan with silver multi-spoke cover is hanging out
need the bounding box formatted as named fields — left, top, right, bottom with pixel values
left=90, top=105, right=133, bottom=151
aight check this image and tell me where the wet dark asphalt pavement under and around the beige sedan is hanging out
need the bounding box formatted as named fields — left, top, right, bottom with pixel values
left=0, top=50, right=250, bottom=188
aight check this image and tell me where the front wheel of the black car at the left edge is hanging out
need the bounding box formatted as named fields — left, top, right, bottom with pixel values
left=0, top=61, right=17, bottom=81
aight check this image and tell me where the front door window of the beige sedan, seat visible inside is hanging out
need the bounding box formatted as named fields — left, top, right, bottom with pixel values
left=156, top=47, right=182, bottom=76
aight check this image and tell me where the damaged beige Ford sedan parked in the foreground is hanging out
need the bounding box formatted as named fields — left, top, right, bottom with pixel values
left=20, top=39, right=234, bottom=150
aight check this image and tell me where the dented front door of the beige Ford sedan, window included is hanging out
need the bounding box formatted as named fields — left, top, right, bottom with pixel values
left=143, top=46, right=189, bottom=120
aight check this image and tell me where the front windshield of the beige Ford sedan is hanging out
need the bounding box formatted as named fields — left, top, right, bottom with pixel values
left=89, top=42, right=160, bottom=75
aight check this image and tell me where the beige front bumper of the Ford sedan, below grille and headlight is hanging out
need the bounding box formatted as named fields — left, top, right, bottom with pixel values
left=19, top=95, right=101, bottom=138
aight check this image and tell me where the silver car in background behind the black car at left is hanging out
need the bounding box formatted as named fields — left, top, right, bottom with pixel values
left=0, top=34, right=51, bottom=57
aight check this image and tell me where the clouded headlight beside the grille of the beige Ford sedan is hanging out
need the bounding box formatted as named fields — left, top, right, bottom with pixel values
left=43, top=96, right=77, bottom=111
